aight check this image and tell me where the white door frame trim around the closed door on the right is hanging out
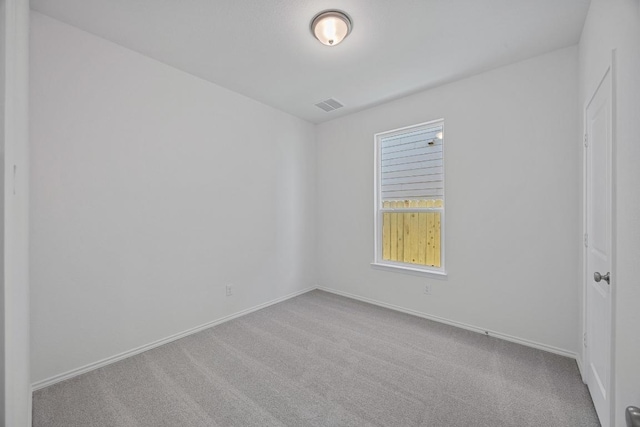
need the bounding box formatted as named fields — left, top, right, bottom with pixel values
left=580, top=49, right=617, bottom=427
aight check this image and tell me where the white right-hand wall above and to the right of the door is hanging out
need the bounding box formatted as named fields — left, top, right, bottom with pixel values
left=580, top=0, right=640, bottom=427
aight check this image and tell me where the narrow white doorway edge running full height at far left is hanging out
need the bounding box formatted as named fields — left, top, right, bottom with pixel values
left=0, top=0, right=31, bottom=426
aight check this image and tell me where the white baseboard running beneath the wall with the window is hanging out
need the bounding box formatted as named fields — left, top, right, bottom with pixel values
left=318, top=286, right=580, bottom=362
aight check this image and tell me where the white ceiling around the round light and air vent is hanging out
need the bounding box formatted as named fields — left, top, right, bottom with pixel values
left=31, top=0, right=589, bottom=123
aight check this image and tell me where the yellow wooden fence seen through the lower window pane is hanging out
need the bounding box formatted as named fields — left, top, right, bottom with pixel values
left=382, top=199, right=443, bottom=267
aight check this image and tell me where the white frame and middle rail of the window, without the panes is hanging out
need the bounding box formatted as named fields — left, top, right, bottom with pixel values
left=371, top=119, right=447, bottom=278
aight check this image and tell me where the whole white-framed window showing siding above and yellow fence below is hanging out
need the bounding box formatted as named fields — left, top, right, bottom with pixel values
left=373, top=120, right=445, bottom=274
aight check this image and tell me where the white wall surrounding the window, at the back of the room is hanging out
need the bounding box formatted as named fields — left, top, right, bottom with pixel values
left=317, top=47, right=581, bottom=353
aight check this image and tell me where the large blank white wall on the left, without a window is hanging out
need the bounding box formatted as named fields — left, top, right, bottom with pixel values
left=31, top=13, right=316, bottom=382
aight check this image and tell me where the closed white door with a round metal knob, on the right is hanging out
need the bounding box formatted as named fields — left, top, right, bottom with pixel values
left=585, top=61, right=615, bottom=427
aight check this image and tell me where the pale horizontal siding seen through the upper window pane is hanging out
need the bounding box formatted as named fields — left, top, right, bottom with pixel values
left=380, top=125, right=444, bottom=202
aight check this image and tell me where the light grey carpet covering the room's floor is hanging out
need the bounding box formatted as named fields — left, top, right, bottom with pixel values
left=33, top=291, right=599, bottom=427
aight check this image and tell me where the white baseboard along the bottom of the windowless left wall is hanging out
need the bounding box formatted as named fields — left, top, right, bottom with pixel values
left=31, top=287, right=316, bottom=391
